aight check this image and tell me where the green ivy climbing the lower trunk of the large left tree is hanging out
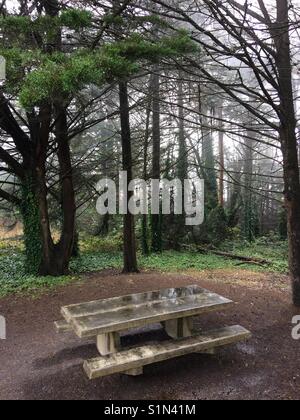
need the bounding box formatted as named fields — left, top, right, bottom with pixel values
left=21, top=179, right=42, bottom=275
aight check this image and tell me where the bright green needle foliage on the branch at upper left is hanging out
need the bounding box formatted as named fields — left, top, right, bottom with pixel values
left=0, top=25, right=194, bottom=110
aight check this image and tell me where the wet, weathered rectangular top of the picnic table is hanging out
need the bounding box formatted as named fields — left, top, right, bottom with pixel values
left=62, top=285, right=233, bottom=338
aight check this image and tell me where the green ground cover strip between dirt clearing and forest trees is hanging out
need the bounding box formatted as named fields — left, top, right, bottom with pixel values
left=0, top=238, right=288, bottom=297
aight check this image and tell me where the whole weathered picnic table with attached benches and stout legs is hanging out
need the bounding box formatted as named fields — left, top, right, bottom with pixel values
left=55, top=285, right=251, bottom=379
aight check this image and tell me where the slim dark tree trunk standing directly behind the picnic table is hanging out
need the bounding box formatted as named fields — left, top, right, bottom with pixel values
left=119, top=81, right=138, bottom=273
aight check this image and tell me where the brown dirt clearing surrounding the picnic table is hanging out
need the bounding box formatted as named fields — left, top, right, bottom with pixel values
left=0, top=271, right=300, bottom=400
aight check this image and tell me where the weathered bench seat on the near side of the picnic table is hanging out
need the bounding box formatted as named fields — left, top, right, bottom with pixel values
left=84, top=325, right=251, bottom=379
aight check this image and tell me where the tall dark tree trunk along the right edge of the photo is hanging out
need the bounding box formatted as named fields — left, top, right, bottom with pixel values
left=274, top=0, right=300, bottom=307
